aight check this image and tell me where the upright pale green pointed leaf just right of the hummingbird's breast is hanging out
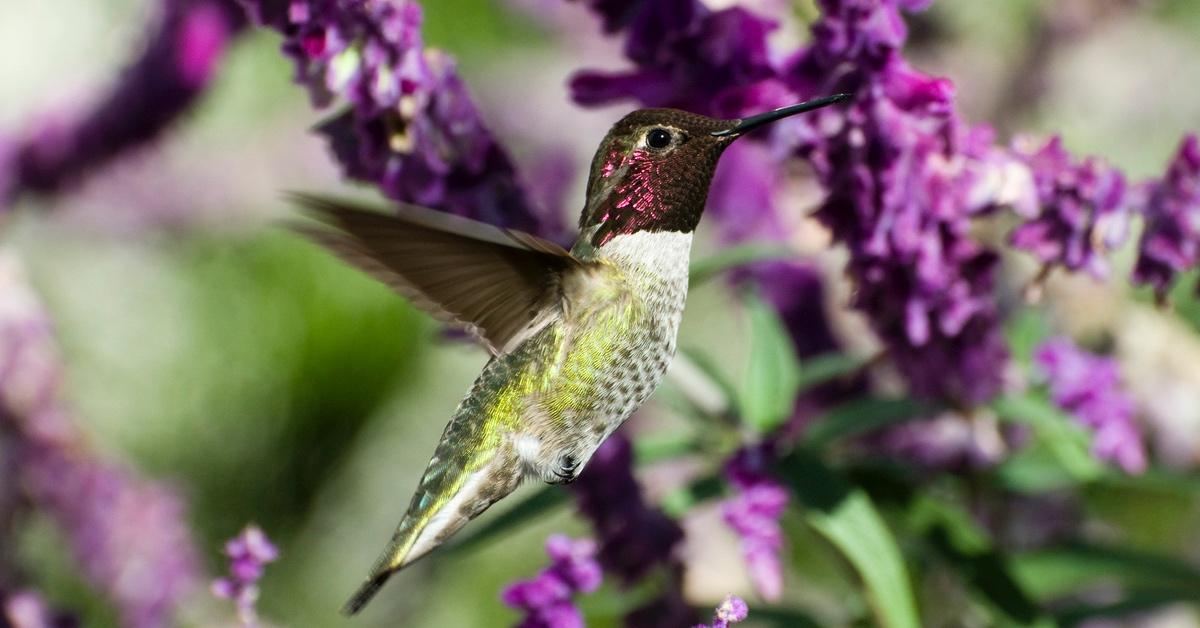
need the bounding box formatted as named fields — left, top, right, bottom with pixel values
left=738, top=295, right=800, bottom=433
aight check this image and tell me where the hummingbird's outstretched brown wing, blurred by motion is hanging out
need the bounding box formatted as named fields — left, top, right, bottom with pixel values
left=293, top=195, right=577, bottom=354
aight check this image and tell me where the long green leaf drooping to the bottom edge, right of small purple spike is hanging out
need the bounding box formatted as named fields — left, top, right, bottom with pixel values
left=779, top=451, right=920, bottom=628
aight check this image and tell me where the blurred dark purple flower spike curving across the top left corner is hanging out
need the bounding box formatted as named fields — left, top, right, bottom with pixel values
left=0, top=0, right=245, bottom=204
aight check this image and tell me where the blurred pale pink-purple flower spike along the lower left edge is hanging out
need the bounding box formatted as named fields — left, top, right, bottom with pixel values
left=0, top=250, right=199, bottom=628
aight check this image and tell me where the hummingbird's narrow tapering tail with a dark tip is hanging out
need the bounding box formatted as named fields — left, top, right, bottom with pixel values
left=342, top=447, right=521, bottom=615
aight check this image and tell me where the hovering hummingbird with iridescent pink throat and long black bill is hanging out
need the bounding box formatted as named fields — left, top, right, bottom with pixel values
left=295, top=94, right=850, bottom=615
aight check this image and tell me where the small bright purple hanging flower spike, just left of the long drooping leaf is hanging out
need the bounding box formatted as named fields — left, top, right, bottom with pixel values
left=721, top=445, right=788, bottom=602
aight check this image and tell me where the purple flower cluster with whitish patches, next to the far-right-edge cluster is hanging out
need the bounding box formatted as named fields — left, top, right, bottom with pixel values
left=1012, top=136, right=1129, bottom=279
